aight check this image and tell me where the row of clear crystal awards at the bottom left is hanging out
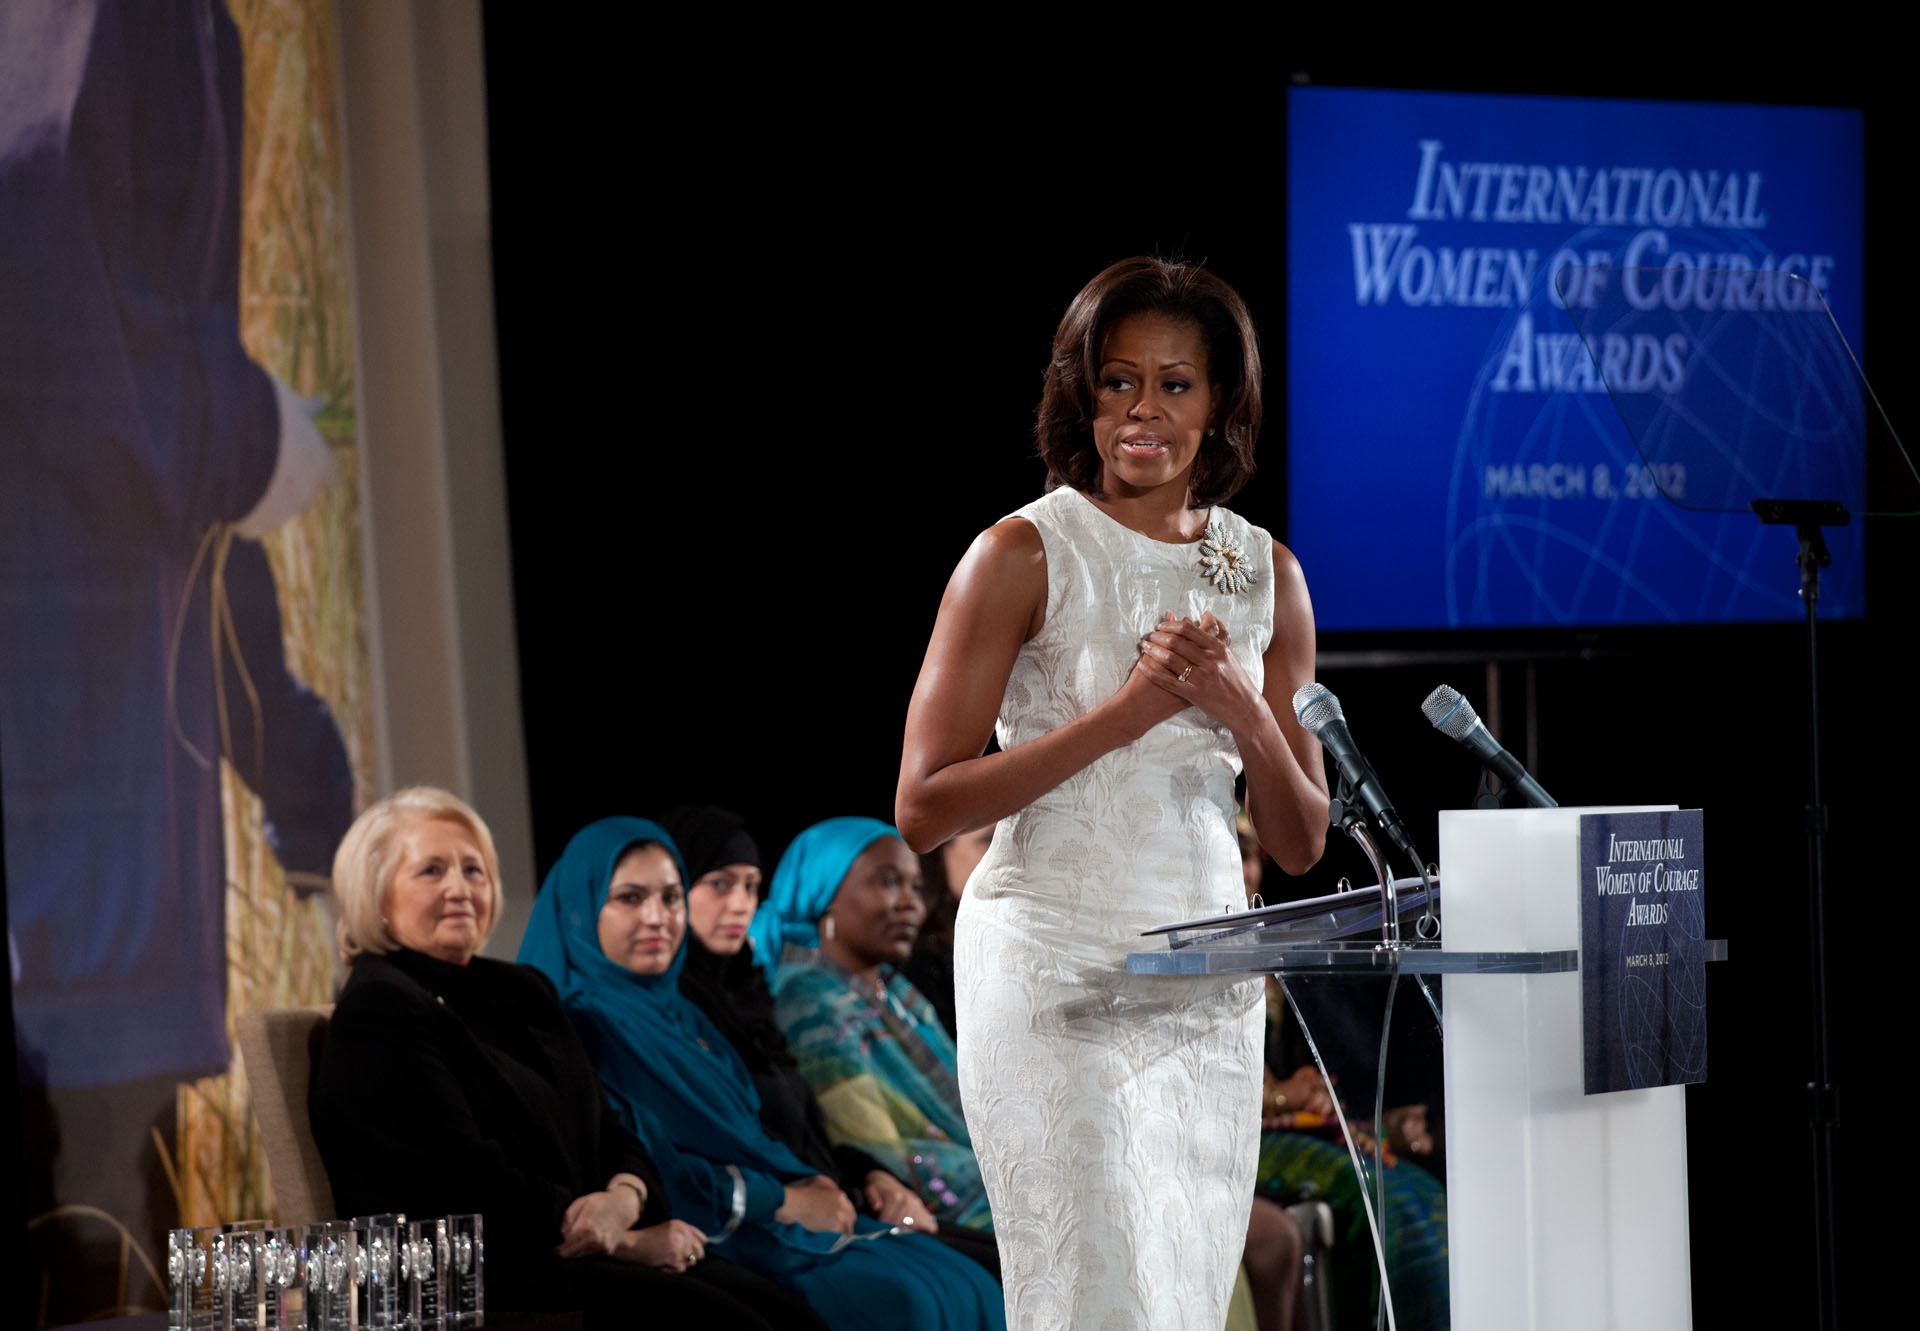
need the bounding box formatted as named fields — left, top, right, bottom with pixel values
left=167, top=1216, right=486, bottom=1331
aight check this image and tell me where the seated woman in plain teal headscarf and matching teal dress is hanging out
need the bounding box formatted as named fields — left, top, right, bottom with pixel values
left=520, top=818, right=1004, bottom=1331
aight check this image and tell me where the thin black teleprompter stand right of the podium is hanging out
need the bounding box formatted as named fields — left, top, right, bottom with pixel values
left=1749, top=499, right=1851, bottom=1331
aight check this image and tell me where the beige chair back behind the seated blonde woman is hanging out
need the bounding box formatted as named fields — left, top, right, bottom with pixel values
left=236, top=1003, right=334, bottom=1225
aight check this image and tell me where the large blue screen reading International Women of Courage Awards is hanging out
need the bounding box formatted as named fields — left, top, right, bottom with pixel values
left=1286, top=86, right=1864, bottom=632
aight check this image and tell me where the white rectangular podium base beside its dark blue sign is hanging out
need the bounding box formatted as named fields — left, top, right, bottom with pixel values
left=1440, top=805, right=1693, bottom=1331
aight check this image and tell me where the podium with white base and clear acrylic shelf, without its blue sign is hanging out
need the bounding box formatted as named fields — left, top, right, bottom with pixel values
left=1127, top=805, right=1726, bottom=1331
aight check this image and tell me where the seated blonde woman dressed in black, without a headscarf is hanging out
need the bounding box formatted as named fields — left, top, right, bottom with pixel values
left=309, top=787, right=822, bottom=1331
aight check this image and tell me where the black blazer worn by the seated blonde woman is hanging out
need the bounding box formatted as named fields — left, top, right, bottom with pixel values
left=309, top=949, right=668, bottom=1270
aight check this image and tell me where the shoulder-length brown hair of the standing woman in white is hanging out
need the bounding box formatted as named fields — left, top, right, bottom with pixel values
left=1035, top=255, right=1260, bottom=509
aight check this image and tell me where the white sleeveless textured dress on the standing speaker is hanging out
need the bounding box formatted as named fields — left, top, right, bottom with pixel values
left=954, top=488, right=1273, bottom=1331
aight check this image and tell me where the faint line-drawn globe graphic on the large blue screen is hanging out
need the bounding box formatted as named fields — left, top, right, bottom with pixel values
left=1444, top=229, right=1864, bottom=626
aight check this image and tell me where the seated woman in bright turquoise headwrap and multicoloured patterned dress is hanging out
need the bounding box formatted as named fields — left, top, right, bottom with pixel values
left=753, top=818, right=993, bottom=1229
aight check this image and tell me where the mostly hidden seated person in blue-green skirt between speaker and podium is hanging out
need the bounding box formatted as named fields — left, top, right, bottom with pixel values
left=1240, top=816, right=1450, bottom=1331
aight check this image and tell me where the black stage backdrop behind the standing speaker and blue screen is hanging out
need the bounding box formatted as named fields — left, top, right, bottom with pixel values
left=486, top=28, right=1920, bottom=1327
